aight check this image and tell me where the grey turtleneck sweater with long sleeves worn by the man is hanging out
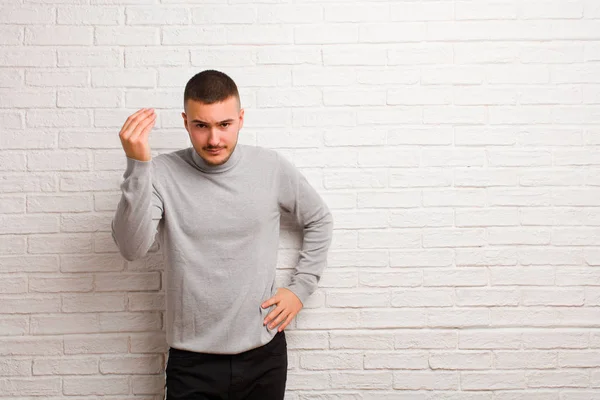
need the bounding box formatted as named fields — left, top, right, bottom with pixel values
left=112, top=144, right=333, bottom=354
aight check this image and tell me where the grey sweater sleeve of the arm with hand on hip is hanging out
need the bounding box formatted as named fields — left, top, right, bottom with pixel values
left=278, top=154, right=333, bottom=304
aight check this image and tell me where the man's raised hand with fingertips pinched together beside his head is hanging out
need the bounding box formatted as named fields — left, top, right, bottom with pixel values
left=119, top=108, right=156, bottom=161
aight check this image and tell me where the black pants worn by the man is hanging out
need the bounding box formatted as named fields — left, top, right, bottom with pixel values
left=166, top=331, right=288, bottom=400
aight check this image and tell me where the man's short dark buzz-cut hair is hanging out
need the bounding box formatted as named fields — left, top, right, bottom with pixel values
left=183, top=69, right=241, bottom=106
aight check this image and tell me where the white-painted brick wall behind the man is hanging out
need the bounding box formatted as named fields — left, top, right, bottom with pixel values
left=0, top=0, right=600, bottom=400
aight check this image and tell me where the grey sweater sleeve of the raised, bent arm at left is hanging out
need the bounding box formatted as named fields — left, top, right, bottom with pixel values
left=111, top=157, right=163, bottom=261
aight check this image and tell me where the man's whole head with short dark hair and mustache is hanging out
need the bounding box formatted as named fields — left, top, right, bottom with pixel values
left=181, top=70, right=244, bottom=165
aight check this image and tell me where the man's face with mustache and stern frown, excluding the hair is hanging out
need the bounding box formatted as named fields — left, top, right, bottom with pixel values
left=181, top=96, right=244, bottom=165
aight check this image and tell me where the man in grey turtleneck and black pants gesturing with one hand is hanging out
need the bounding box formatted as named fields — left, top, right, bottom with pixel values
left=112, top=70, right=333, bottom=400
